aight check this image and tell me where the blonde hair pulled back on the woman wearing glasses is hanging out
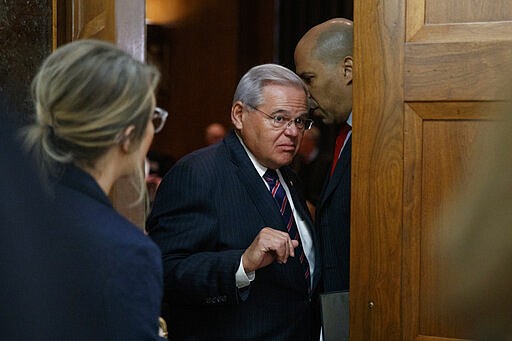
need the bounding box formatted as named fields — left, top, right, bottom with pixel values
left=25, top=40, right=160, bottom=203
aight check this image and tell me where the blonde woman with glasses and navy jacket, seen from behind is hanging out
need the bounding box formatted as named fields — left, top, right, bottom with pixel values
left=25, top=40, right=167, bottom=340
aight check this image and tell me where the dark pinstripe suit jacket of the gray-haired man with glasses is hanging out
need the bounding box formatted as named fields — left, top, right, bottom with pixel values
left=147, top=132, right=319, bottom=340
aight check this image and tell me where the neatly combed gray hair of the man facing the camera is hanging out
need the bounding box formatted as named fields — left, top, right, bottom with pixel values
left=233, top=64, right=309, bottom=107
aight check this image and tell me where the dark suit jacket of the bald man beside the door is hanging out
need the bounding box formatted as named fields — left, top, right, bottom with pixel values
left=315, top=135, right=352, bottom=292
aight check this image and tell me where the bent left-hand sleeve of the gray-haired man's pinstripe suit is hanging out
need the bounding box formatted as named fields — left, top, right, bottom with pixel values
left=147, top=163, right=244, bottom=305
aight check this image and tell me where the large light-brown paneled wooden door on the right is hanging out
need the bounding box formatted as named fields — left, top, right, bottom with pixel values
left=350, top=0, right=512, bottom=341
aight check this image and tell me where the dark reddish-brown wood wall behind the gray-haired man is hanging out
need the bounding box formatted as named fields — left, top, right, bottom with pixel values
left=148, top=0, right=274, bottom=159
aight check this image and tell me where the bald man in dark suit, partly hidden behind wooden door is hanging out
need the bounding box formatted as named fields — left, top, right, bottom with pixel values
left=294, top=19, right=353, bottom=293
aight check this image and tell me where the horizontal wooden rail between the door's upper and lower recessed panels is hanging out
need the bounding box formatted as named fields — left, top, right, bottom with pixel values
left=404, top=41, right=512, bottom=101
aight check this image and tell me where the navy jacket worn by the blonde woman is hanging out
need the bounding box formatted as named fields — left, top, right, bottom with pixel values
left=48, top=166, right=163, bottom=340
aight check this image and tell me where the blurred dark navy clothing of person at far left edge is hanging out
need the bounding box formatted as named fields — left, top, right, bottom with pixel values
left=0, top=120, right=68, bottom=340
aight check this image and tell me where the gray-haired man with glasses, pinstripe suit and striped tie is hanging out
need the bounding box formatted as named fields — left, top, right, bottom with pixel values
left=147, top=64, right=320, bottom=340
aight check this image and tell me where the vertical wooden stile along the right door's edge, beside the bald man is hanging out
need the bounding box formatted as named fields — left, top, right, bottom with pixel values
left=350, top=0, right=405, bottom=340
